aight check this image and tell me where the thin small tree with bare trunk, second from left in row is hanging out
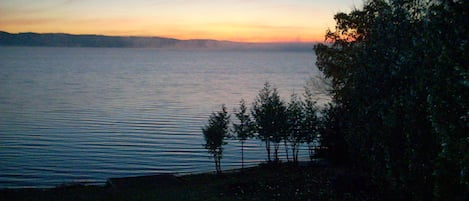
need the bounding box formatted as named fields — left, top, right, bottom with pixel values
left=233, top=99, right=254, bottom=168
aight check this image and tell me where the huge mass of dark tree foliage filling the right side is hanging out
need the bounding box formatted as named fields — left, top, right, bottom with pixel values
left=315, top=0, right=469, bottom=200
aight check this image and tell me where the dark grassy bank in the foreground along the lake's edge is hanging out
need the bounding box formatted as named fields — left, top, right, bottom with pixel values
left=0, top=164, right=379, bottom=201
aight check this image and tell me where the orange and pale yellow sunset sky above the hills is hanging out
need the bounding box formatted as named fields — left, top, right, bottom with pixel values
left=0, top=0, right=363, bottom=42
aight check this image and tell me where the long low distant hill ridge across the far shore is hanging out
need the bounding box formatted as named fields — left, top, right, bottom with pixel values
left=0, top=31, right=312, bottom=50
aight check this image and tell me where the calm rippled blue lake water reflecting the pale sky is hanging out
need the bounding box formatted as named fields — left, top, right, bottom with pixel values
left=0, top=47, right=328, bottom=188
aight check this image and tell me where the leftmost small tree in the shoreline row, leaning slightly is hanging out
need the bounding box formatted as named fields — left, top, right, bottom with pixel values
left=202, top=105, right=230, bottom=173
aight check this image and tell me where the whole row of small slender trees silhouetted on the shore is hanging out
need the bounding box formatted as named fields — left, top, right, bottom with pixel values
left=202, top=82, right=321, bottom=172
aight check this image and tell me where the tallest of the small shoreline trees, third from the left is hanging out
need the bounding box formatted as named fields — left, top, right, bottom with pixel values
left=251, top=82, right=286, bottom=162
